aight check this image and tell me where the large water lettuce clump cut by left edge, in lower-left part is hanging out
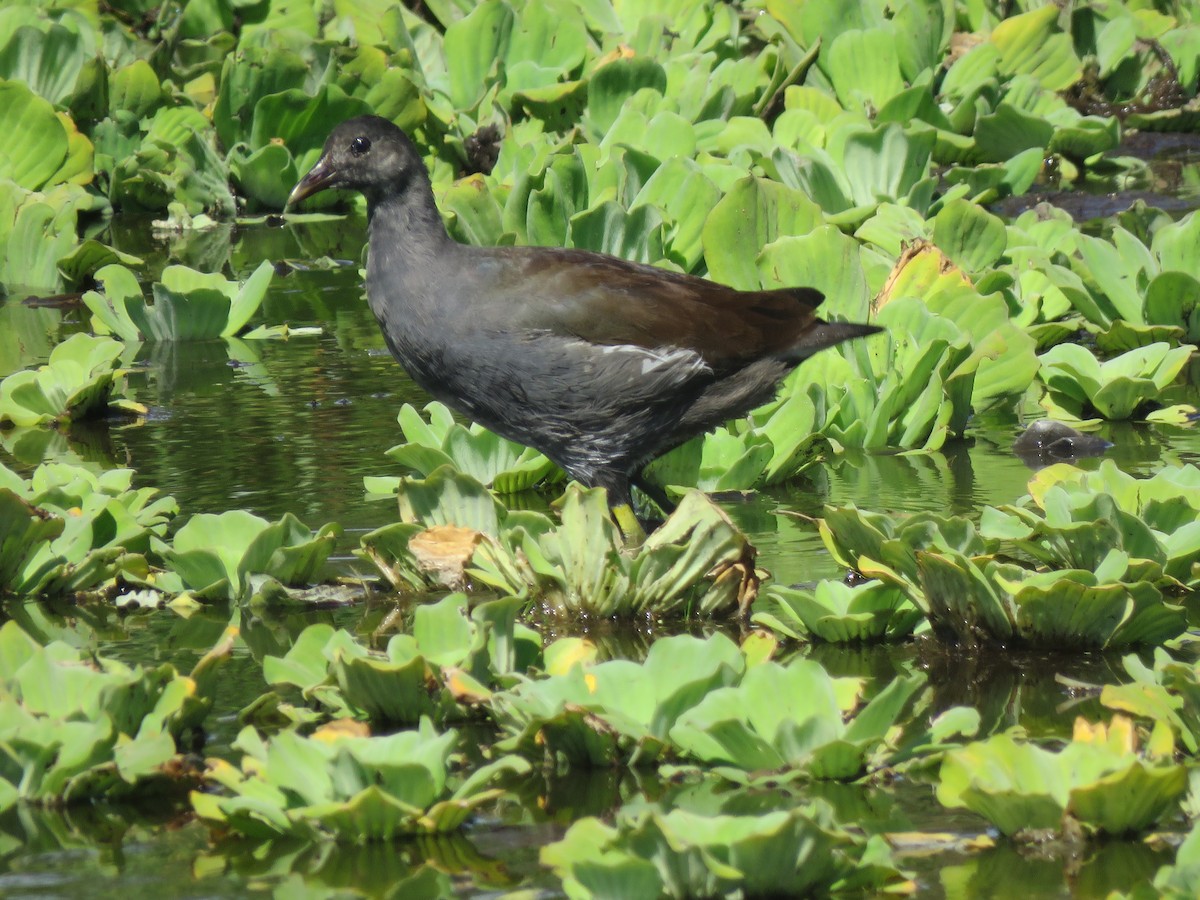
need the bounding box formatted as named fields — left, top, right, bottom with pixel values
left=0, top=622, right=215, bottom=809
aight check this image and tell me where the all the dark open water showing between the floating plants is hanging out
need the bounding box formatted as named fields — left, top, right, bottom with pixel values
left=0, top=207, right=1200, bottom=898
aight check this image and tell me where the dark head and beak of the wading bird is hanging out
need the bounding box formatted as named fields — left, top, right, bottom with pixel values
left=288, top=115, right=426, bottom=206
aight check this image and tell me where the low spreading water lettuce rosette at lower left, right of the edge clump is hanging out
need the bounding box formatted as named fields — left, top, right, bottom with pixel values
left=191, top=720, right=529, bottom=844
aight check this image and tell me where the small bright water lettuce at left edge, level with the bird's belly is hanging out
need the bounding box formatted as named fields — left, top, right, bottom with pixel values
left=0, top=334, right=145, bottom=426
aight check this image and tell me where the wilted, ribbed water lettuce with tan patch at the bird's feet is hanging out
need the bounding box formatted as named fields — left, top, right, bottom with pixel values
left=361, top=467, right=757, bottom=618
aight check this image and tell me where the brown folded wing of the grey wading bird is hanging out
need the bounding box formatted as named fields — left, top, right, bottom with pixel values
left=496, top=247, right=835, bottom=372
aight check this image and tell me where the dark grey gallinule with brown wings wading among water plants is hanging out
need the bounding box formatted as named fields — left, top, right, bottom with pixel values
left=288, top=115, right=880, bottom=536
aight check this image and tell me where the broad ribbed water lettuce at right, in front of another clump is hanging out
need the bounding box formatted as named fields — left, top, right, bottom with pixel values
left=821, top=494, right=1187, bottom=649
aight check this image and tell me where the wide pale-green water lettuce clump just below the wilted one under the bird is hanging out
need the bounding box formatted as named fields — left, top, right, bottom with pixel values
left=491, top=635, right=923, bottom=781
